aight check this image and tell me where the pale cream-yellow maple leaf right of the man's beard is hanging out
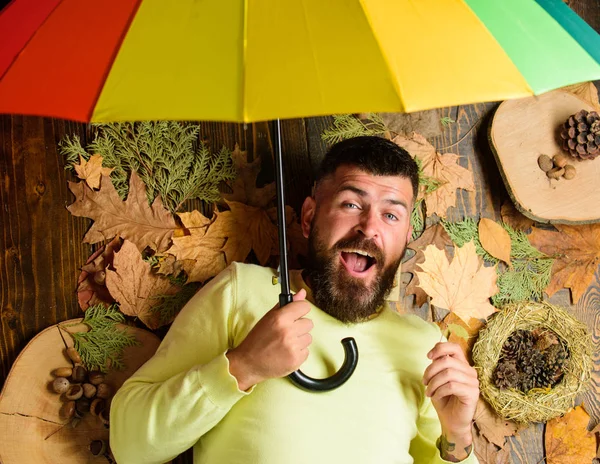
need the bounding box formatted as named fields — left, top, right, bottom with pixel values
left=416, top=242, right=498, bottom=324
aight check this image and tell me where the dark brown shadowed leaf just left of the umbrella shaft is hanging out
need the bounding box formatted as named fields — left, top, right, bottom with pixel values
left=223, top=144, right=275, bottom=208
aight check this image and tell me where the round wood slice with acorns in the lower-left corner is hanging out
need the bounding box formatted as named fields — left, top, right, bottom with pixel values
left=0, top=319, right=160, bottom=464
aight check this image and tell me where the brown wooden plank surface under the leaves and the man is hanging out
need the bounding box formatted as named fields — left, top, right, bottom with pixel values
left=0, top=0, right=600, bottom=464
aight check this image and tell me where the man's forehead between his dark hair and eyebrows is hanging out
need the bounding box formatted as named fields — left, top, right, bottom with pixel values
left=317, top=165, right=413, bottom=199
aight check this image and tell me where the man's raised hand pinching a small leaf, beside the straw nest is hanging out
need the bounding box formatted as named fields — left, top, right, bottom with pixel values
left=423, top=342, right=479, bottom=456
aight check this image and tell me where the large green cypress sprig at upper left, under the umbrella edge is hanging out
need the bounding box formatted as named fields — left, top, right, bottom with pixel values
left=59, top=121, right=236, bottom=212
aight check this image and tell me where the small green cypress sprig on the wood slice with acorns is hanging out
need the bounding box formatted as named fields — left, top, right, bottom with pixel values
left=62, top=304, right=139, bottom=372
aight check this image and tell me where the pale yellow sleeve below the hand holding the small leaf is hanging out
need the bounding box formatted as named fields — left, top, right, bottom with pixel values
left=409, top=397, right=479, bottom=464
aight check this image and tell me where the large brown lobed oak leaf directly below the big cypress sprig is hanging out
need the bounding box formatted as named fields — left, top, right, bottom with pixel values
left=67, top=172, right=177, bottom=252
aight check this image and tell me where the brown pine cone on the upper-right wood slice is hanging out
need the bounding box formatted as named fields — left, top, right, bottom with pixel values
left=560, top=110, right=600, bottom=159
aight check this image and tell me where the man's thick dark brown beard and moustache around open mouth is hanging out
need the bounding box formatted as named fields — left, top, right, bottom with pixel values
left=305, top=224, right=402, bottom=324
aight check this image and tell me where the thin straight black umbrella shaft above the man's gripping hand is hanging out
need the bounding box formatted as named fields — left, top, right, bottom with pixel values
left=275, top=119, right=292, bottom=307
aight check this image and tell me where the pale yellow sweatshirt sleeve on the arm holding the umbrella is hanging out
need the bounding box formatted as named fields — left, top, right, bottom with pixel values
left=110, top=266, right=249, bottom=464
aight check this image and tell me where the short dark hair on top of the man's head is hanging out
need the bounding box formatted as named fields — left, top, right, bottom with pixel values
left=316, top=136, right=419, bottom=201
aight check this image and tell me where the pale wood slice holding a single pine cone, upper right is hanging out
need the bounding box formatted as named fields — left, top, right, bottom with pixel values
left=489, top=90, right=600, bottom=224
